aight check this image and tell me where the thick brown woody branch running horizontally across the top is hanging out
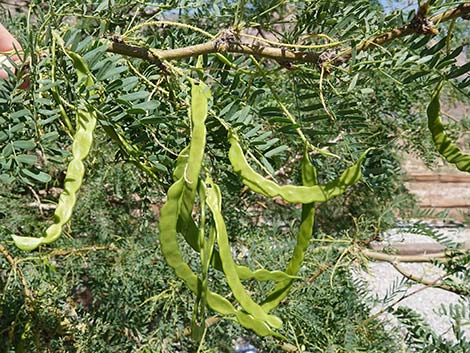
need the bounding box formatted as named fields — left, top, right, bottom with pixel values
left=108, top=3, right=470, bottom=65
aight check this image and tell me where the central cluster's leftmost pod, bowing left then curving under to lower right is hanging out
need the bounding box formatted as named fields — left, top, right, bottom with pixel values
left=159, top=178, right=285, bottom=339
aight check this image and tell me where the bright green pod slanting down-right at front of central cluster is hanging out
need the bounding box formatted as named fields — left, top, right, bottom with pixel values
left=207, top=181, right=282, bottom=328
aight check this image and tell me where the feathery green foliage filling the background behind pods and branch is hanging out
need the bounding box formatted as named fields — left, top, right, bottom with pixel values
left=0, top=0, right=470, bottom=352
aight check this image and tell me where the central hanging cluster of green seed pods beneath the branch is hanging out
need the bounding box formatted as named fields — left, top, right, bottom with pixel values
left=160, top=83, right=366, bottom=339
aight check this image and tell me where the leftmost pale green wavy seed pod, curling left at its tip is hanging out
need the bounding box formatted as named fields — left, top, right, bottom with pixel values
left=12, top=53, right=96, bottom=251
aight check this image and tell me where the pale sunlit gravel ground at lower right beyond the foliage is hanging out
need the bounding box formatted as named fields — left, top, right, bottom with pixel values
left=356, top=227, right=470, bottom=339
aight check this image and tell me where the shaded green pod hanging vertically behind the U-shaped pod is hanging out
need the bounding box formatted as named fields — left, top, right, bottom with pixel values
left=262, top=151, right=317, bottom=312
